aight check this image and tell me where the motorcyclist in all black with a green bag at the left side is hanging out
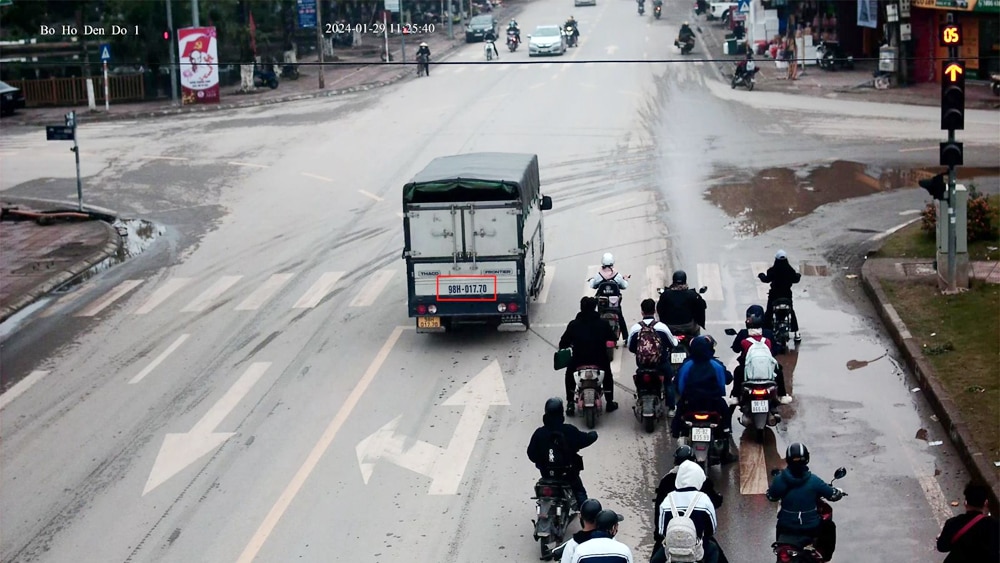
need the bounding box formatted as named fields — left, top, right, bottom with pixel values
left=559, top=297, right=618, bottom=416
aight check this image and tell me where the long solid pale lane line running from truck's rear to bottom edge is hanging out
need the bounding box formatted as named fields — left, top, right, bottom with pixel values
left=236, top=326, right=413, bottom=563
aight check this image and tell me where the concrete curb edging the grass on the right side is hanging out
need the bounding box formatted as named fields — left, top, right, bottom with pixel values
left=861, top=258, right=1000, bottom=506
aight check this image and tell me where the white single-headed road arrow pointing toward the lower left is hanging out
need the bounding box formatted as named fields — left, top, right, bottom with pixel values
left=142, top=362, right=271, bottom=496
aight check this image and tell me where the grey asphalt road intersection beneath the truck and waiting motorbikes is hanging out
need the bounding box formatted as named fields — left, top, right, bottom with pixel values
left=0, top=1, right=997, bottom=563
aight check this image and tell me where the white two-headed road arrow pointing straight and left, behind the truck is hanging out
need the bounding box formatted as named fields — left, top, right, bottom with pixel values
left=355, top=360, right=510, bottom=495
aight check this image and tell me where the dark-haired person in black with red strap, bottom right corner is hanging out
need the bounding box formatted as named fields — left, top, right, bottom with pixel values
left=937, top=483, right=1000, bottom=563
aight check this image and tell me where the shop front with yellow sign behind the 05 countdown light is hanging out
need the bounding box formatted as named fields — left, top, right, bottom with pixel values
left=911, top=0, right=1000, bottom=82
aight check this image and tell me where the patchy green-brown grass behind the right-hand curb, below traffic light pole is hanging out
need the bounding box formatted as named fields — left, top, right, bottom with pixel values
left=882, top=280, right=1000, bottom=462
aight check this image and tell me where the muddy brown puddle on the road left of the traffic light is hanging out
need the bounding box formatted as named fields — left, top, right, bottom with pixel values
left=706, top=160, right=1000, bottom=238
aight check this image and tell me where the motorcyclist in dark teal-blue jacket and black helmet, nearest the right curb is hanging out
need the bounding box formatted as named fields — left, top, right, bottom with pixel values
left=767, top=442, right=844, bottom=561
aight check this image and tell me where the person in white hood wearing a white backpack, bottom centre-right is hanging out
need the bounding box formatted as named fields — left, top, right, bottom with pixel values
left=649, top=460, right=728, bottom=563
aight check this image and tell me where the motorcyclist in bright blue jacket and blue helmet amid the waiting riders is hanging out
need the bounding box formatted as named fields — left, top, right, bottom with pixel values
left=670, top=336, right=733, bottom=438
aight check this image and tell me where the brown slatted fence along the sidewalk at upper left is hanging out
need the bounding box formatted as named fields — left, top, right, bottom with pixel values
left=7, top=73, right=146, bottom=107
